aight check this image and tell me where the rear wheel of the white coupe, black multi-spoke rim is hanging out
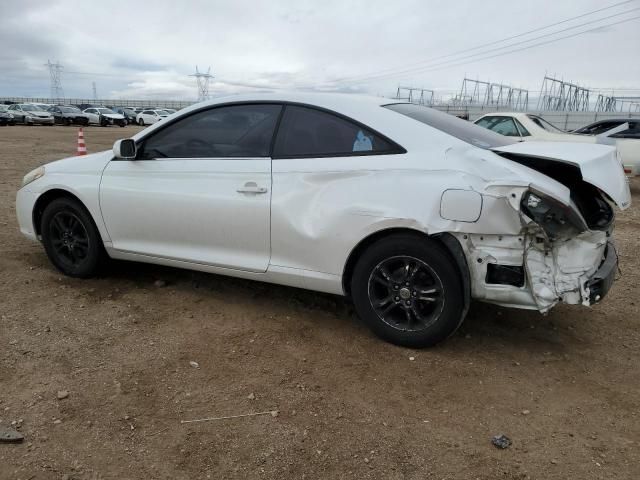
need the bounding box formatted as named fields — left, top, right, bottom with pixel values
left=351, top=233, right=464, bottom=348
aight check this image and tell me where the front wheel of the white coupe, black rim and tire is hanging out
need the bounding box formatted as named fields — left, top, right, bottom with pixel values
left=40, top=198, right=106, bottom=278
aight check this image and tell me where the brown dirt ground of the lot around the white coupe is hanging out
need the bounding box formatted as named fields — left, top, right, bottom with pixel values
left=0, top=126, right=640, bottom=480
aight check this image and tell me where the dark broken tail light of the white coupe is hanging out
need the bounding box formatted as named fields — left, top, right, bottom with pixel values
left=520, top=190, right=588, bottom=240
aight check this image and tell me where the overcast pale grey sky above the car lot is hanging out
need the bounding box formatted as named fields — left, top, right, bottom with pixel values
left=0, top=0, right=640, bottom=100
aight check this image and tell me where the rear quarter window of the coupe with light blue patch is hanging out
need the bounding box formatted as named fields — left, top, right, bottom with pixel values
left=273, top=105, right=401, bottom=158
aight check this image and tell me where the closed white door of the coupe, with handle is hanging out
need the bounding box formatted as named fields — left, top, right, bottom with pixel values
left=100, top=158, right=271, bottom=272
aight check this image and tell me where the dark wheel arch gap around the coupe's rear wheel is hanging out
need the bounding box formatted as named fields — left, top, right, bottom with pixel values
left=342, top=227, right=471, bottom=318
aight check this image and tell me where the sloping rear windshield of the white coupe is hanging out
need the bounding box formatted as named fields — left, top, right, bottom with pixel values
left=384, top=103, right=517, bottom=150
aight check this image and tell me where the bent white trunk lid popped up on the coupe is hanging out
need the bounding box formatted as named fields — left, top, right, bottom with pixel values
left=492, top=142, right=631, bottom=210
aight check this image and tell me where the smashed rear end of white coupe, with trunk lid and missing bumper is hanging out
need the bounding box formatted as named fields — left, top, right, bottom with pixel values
left=458, top=142, right=631, bottom=313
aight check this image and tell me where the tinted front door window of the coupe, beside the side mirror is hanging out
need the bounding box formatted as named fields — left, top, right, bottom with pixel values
left=138, top=104, right=282, bottom=159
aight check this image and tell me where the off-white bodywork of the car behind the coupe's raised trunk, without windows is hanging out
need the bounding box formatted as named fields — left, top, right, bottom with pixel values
left=474, top=112, right=640, bottom=176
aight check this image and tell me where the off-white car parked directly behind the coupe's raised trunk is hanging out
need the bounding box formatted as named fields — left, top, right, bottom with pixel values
left=474, top=112, right=640, bottom=176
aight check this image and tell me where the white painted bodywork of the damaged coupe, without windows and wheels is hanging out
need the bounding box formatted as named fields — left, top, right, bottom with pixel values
left=17, top=94, right=630, bottom=312
